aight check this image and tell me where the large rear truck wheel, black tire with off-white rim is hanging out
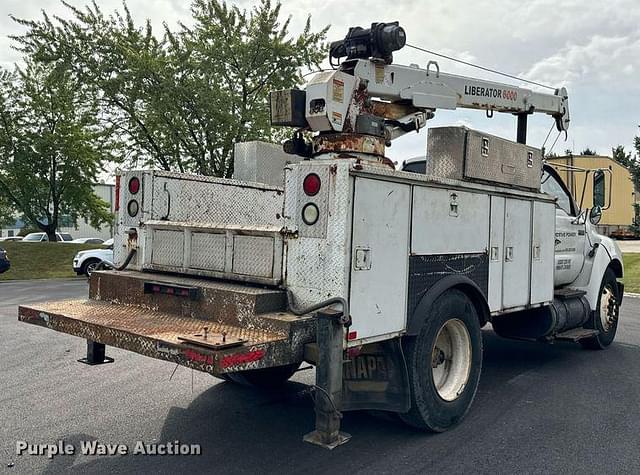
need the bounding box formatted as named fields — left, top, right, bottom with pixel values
left=400, top=289, right=482, bottom=432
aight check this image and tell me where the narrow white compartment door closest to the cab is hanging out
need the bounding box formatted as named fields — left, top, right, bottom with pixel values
left=531, top=201, right=556, bottom=304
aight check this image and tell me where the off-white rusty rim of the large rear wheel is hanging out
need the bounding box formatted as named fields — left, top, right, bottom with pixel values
left=431, top=318, right=471, bottom=401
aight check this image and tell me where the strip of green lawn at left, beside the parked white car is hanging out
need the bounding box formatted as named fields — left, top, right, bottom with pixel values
left=0, top=242, right=100, bottom=280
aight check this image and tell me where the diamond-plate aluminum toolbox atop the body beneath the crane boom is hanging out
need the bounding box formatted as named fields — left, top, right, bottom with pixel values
left=426, top=127, right=542, bottom=190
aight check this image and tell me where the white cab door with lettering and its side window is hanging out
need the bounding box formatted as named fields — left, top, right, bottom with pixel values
left=542, top=167, right=586, bottom=287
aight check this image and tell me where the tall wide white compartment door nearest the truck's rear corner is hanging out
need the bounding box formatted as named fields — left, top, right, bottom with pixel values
left=350, top=177, right=411, bottom=340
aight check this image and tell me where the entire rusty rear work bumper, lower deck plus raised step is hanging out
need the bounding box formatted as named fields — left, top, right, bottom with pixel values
left=18, top=271, right=316, bottom=375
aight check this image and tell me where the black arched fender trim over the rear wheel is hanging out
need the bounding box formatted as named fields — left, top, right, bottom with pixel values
left=406, top=275, right=489, bottom=336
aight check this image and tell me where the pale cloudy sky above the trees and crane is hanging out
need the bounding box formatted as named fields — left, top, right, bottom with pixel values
left=0, top=0, right=640, bottom=161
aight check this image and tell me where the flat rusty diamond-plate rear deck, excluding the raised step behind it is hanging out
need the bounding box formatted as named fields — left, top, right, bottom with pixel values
left=18, top=300, right=314, bottom=374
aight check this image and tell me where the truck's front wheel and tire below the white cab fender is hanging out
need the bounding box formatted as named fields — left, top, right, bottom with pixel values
left=580, top=269, right=620, bottom=350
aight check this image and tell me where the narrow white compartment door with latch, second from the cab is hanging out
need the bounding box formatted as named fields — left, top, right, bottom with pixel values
left=502, top=198, right=531, bottom=309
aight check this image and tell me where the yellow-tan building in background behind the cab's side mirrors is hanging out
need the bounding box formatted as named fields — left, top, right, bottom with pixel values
left=547, top=155, right=638, bottom=236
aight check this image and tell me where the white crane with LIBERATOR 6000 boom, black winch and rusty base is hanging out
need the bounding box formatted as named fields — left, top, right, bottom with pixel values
left=271, top=22, right=570, bottom=157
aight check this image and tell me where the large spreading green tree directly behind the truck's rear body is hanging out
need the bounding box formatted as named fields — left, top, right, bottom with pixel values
left=14, top=0, right=328, bottom=177
